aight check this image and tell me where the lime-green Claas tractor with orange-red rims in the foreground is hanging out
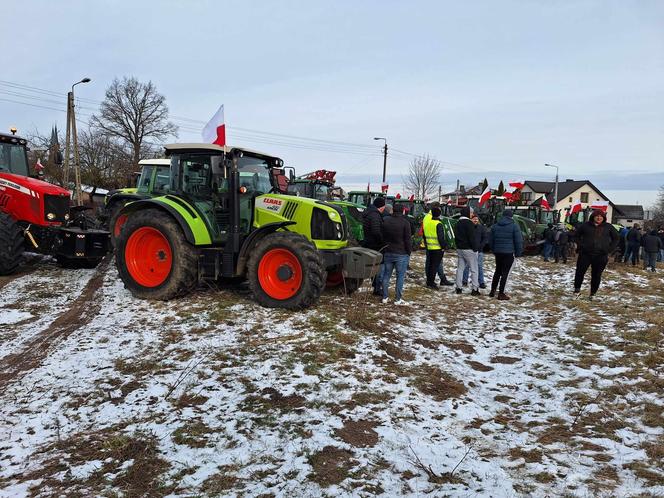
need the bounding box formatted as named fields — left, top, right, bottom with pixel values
left=116, top=144, right=381, bottom=309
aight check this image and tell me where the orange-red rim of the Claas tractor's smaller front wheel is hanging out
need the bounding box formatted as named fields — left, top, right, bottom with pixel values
left=258, top=249, right=302, bottom=300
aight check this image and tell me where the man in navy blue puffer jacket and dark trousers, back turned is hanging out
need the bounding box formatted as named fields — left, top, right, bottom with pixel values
left=489, top=210, right=523, bottom=301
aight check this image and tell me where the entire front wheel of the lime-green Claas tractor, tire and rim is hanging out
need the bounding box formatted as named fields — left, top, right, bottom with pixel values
left=247, top=232, right=326, bottom=310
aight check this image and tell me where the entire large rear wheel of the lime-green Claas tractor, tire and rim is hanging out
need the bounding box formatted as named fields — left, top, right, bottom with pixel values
left=115, top=209, right=198, bottom=301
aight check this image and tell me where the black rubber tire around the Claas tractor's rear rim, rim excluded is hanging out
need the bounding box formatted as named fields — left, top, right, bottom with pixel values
left=115, top=209, right=198, bottom=301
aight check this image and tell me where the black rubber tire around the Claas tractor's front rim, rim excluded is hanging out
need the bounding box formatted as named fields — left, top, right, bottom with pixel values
left=247, top=232, right=327, bottom=310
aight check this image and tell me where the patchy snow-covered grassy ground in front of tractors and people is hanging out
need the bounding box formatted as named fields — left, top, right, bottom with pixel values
left=0, top=254, right=664, bottom=497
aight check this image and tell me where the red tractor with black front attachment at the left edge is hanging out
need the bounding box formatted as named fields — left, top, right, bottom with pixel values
left=0, top=130, right=109, bottom=275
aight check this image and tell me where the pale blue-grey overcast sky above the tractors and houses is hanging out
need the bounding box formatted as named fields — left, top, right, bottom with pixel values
left=0, top=0, right=664, bottom=194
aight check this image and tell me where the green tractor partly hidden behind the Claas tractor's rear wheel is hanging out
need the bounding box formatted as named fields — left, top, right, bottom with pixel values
left=104, top=159, right=171, bottom=247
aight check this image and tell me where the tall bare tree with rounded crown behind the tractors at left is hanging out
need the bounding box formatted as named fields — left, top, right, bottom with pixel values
left=90, top=76, right=177, bottom=165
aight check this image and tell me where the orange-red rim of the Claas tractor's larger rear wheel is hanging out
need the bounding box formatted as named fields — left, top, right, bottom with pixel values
left=125, top=227, right=173, bottom=287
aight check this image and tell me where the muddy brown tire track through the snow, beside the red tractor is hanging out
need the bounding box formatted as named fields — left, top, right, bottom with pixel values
left=0, top=256, right=112, bottom=390
